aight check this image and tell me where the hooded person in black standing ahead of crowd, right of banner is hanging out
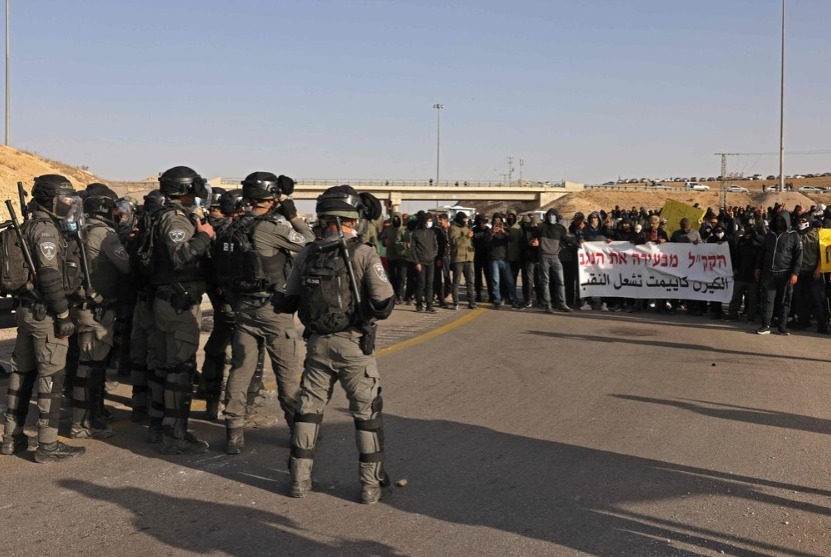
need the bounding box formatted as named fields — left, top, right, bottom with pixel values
left=755, top=210, right=802, bottom=335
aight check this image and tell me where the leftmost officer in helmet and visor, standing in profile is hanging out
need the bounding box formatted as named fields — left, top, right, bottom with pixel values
left=0, top=174, right=86, bottom=462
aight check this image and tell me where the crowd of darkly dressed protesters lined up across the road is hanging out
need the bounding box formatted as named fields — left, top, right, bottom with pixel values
left=377, top=204, right=831, bottom=334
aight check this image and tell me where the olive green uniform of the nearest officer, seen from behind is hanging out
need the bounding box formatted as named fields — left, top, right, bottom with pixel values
left=286, top=229, right=394, bottom=486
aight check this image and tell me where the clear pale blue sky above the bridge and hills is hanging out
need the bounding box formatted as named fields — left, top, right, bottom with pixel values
left=10, top=0, right=831, bottom=183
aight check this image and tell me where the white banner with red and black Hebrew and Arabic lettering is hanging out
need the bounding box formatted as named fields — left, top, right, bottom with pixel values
left=577, top=242, right=733, bottom=302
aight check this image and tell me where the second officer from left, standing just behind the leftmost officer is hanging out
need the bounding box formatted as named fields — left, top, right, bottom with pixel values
left=70, top=185, right=130, bottom=439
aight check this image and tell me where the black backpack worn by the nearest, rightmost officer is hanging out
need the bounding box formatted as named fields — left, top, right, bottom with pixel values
left=298, top=236, right=360, bottom=335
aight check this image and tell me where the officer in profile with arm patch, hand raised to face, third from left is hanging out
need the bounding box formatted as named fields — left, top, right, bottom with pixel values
left=149, top=166, right=214, bottom=454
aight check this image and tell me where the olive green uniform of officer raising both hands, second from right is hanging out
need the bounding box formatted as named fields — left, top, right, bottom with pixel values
left=225, top=214, right=314, bottom=430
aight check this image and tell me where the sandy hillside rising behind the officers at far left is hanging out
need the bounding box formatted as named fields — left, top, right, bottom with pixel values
left=0, top=145, right=109, bottom=216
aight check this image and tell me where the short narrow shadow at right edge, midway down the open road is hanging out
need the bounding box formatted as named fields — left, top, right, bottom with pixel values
left=610, top=394, right=831, bottom=435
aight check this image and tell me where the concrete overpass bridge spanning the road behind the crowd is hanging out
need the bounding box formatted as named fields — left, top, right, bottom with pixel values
left=208, top=178, right=584, bottom=211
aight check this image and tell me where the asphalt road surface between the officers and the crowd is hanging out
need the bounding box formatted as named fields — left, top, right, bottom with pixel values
left=0, top=307, right=831, bottom=557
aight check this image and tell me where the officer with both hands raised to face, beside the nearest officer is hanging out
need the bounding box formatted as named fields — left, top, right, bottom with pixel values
left=215, top=172, right=314, bottom=454
